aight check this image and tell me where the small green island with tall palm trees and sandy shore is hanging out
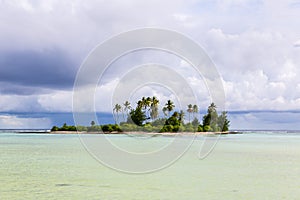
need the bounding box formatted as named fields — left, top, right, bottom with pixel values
left=51, top=96, right=230, bottom=134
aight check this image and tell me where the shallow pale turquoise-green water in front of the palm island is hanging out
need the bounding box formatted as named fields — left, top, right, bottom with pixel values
left=0, top=133, right=300, bottom=200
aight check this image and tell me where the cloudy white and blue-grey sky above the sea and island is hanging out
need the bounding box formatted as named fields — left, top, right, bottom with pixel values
left=0, top=0, right=300, bottom=129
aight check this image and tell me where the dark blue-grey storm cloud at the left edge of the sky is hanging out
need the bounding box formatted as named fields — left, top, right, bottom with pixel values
left=0, top=49, right=79, bottom=94
